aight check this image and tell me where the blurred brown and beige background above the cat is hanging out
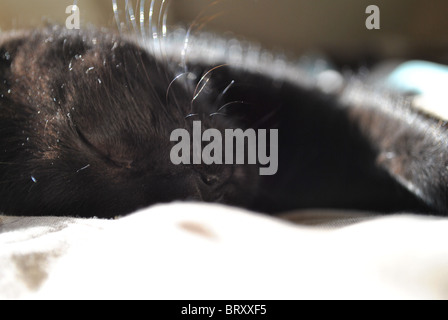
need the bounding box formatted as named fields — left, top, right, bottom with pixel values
left=0, top=0, right=448, bottom=63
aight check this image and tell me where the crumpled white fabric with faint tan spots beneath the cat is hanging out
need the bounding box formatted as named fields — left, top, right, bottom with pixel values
left=0, top=203, right=448, bottom=300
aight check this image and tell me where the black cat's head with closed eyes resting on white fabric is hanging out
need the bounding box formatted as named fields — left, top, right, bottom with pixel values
left=0, top=28, right=258, bottom=216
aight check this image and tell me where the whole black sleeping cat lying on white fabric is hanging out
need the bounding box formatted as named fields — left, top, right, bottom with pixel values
left=0, top=21, right=442, bottom=217
